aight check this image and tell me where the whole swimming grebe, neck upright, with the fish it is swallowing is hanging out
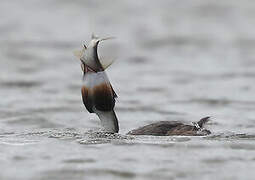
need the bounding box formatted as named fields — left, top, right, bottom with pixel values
left=74, top=34, right=211, bottom=136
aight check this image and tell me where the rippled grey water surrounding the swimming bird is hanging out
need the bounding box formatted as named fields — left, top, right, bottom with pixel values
left=0, top=0, right=255, bottom=180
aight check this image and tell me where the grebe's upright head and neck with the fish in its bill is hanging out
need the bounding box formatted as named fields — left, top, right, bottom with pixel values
left=74, top=34, right=119, bottom=133
